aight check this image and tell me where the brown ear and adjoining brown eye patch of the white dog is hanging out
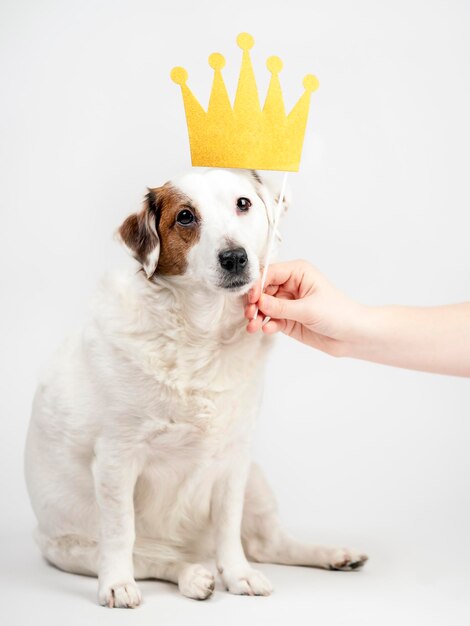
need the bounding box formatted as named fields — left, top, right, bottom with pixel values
left=119, top=183, right=200, bottom=278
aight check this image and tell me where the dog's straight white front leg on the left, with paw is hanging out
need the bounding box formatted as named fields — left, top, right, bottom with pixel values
left=93, top=439, right=141, bottom=608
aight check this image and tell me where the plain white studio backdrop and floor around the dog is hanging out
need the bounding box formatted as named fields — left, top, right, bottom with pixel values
left=0, top=0, right=470, bottom=626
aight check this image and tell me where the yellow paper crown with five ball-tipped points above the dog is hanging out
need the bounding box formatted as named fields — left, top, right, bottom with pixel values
left=171, top=33, right=318, bottom=172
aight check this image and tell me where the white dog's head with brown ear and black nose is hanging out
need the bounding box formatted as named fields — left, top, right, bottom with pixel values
left=119, top=169, right=286, bottom=294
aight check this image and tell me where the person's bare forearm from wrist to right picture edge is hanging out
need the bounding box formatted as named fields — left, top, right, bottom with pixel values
left=345, top=302, right=470, bottom=376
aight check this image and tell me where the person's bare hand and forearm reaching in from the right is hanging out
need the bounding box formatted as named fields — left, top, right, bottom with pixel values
left=245, top=261, right=470, bottom=376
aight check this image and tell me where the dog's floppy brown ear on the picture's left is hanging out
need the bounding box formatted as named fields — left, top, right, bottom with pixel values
left=118, top=188, right=161, bottom=278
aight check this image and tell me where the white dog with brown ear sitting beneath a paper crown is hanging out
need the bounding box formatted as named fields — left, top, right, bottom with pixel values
left=26, top=170, right=367, bottom=607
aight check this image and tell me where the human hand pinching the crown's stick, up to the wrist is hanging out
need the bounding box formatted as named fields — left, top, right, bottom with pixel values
left=245, top=261, right=366, bottom=356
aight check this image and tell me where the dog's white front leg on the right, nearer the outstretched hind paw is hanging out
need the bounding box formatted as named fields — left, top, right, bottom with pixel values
left=212, top=452, right=272, bottom=596
